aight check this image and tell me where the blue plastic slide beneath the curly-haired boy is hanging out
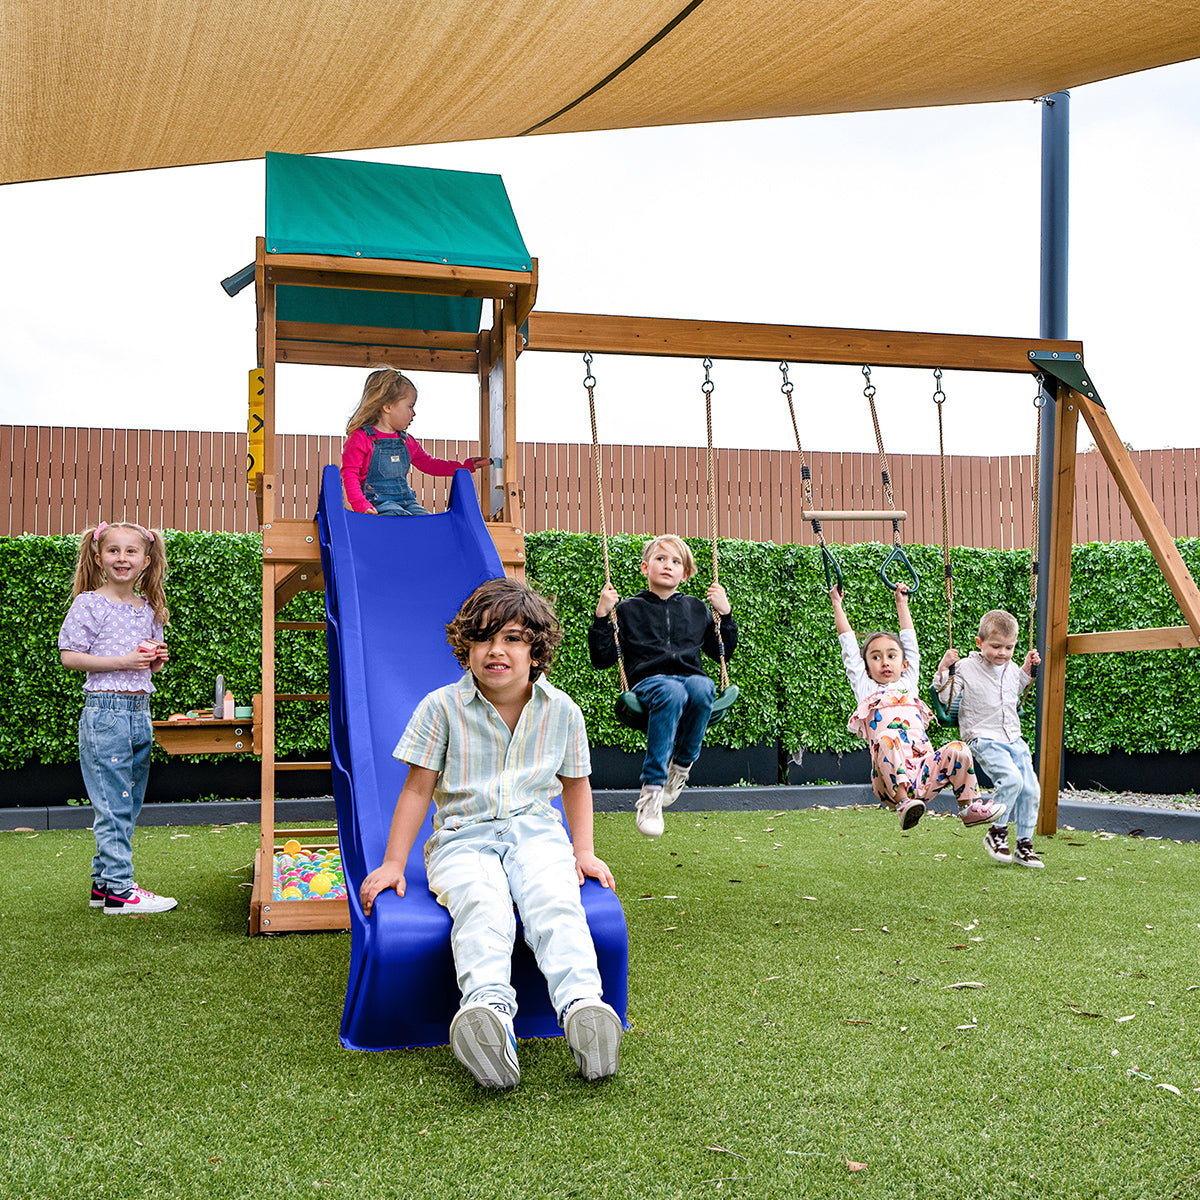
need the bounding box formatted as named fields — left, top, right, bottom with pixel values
left=317, top=467, right=629, bottom=1050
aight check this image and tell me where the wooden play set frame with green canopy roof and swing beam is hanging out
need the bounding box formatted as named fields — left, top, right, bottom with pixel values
left=147, top=155, right=1200, bottom=934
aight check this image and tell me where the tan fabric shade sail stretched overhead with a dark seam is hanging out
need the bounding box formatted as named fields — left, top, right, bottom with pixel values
left=0, top=0, right=1200, bottom=182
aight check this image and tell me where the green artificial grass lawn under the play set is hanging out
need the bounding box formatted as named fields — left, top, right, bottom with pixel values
left=0, top=809, right=1200, bottom=1200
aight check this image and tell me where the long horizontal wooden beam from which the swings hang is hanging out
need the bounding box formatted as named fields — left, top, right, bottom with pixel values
left=528, top=312, right=1082, bottom=373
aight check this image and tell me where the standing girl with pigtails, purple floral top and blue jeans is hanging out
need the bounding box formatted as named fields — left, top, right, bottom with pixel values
left=59, top=522, right=175, bottom=916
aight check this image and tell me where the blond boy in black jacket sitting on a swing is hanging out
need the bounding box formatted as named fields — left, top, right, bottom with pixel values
left=588, top=534, right=738, bottom=838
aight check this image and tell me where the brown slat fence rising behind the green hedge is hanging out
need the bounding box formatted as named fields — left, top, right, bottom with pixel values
left=0, top=425, right=1200, bottom=550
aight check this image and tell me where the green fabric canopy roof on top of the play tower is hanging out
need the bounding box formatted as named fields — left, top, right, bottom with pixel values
left=266, top=152, right=532, bottom=332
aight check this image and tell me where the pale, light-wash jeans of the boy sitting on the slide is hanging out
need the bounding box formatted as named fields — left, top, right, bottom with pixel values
left=426, top=814, right=602, bottom=1015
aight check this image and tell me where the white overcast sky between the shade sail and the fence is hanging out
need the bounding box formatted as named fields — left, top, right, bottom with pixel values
left=0, top=62, right=1200, bottom=454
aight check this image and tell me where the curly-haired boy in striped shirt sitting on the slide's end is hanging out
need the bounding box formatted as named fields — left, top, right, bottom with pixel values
left=360, top=578, right=624, bottom=1088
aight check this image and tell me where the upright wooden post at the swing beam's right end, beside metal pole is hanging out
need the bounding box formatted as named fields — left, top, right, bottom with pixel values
left=1038, top=383, right=1079, bottom=835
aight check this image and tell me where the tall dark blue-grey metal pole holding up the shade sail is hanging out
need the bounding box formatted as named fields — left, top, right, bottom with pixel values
left=1037, top=91, right=1070, bottom=784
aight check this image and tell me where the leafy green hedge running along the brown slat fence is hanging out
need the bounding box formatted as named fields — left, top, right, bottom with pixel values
left=0, top=533, right=1200, bottom=769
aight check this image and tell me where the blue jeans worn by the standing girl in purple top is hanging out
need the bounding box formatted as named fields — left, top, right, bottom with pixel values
left=79, top=692, right=154, bottom=892
